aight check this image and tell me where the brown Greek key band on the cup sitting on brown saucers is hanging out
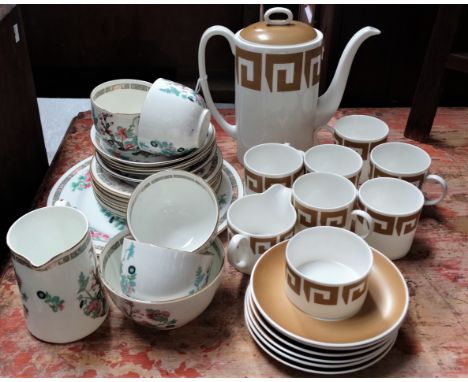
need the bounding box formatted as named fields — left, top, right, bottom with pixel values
left=286, top=264, right=367, bottom=306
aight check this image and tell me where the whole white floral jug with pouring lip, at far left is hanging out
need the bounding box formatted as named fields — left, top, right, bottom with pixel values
left=6, top=206, right=108, bottom=343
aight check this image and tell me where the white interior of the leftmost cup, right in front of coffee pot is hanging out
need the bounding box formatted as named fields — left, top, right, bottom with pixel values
left=244, top=143, right=303, bottom=177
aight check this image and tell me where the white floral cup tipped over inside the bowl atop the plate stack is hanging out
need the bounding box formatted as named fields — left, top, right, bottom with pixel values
left=138, top=78, right=211, bottom=157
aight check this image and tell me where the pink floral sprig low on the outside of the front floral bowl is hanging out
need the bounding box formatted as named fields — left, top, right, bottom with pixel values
left=114, top=300, right=177, bottom=329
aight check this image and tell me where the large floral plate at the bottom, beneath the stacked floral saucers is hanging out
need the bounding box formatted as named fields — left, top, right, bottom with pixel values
left=47, top=157, right=244, bottom=253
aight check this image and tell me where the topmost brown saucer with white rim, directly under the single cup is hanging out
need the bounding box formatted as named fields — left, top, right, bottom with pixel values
left=251, top=242, right=409, bottom=348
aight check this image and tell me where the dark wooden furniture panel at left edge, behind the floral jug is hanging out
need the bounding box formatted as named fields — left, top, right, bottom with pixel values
left=0, top=5, right=48, bottom=266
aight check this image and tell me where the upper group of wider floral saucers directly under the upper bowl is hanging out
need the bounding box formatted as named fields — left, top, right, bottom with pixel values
left=91, top=125, right=223, bottom=185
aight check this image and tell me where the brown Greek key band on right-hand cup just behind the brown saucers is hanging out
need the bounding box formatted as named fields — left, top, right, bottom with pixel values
left=357, top=202, right=421, bottom=236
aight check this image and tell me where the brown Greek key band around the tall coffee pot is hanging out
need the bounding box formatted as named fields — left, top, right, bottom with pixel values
left=235, top=46, right=323, bottom=93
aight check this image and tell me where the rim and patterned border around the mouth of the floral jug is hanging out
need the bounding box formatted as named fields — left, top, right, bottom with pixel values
left=6, top=206, right=91, bottom=271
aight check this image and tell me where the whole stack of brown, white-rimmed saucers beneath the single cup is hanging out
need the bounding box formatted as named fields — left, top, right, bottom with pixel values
left=244, top=242, right=409, bottom=374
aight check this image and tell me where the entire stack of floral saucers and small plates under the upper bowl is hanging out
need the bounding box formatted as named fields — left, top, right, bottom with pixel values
left=90, top=125, right=223, bottom=217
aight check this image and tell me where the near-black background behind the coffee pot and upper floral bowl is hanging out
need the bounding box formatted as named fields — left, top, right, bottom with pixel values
left=21, top=5, right=468, bottom=107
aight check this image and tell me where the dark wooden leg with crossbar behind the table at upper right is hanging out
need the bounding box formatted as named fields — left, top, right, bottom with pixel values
left=405, top=5, right=468, bottom=141
